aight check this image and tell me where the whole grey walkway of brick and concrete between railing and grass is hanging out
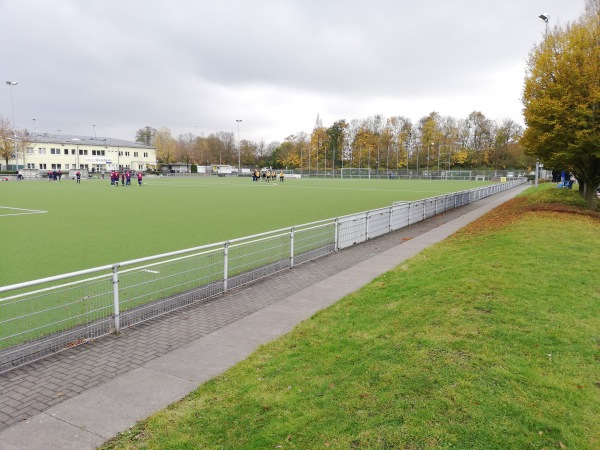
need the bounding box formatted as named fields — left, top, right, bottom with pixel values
left=0, top=185, right=527, bottom=450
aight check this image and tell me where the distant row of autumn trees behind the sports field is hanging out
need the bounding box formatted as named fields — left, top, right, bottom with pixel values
left=136, top=111, right=535, bottom=173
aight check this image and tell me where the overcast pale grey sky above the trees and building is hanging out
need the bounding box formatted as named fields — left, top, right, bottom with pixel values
left=0, top=0, right=584, bottom=143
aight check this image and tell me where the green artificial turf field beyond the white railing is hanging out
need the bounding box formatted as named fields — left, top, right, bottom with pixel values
left=0, top=177, right=490, bottom=286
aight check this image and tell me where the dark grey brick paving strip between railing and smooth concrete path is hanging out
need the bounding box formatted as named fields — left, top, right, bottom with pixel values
left=0, top=194, right=510, bottom=429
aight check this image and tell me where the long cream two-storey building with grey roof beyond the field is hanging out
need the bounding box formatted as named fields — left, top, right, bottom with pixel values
left=2, top=133, right=156, bottom=173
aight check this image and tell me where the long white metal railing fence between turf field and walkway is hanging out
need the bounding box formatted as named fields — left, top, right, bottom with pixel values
left=0, top=179, right=526, bottom=373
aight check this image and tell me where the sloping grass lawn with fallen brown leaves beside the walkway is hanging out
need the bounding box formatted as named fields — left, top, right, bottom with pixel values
left=105, top=189, right=600, bottom=449
